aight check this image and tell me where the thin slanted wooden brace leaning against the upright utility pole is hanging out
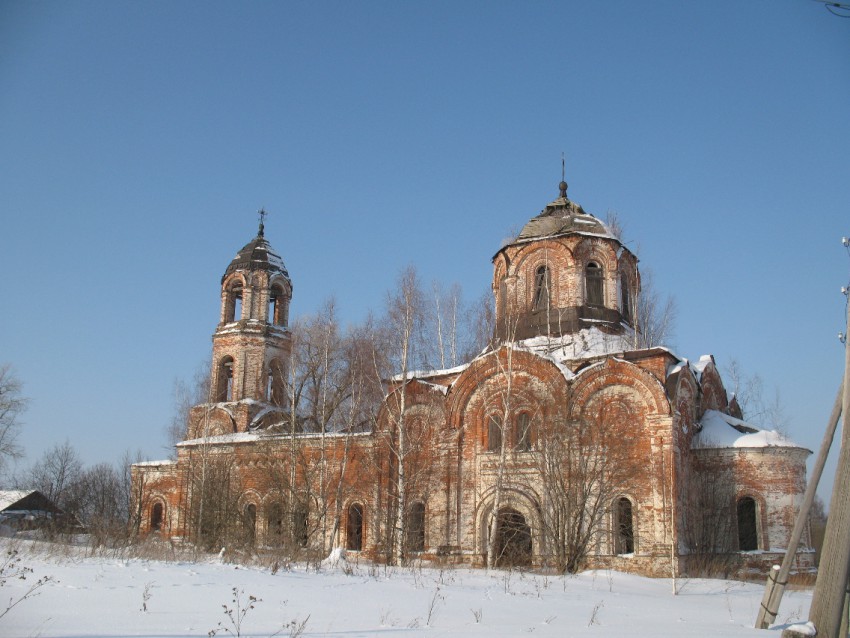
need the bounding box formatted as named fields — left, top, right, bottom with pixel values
left=756, top=381, right=844, bottom=629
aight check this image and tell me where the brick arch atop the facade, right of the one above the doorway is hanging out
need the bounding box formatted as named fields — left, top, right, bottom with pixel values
left=570, top=358, right=671, bottom=418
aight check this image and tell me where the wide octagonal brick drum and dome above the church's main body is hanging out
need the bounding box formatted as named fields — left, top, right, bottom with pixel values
left=493, top=180, right=640, bottom=348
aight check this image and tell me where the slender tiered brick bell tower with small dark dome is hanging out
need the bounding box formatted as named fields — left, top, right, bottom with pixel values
left=189, top=210, right=292, bottom=438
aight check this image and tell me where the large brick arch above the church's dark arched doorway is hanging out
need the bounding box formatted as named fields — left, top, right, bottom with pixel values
left=447, top=346, right=568, bottom=431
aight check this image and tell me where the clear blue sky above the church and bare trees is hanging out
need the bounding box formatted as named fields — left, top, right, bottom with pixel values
left=0, top=0, right=850, bottom=500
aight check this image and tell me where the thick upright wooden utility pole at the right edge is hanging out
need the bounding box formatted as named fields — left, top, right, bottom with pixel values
left=809, top=303, right=850, bottom=638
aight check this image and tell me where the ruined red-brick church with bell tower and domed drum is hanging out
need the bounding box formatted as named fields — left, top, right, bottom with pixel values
left=133, top=182, right=812, bottom=576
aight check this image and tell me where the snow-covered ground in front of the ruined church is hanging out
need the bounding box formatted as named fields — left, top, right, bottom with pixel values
left=0, top=539, right=811, bottom=638
